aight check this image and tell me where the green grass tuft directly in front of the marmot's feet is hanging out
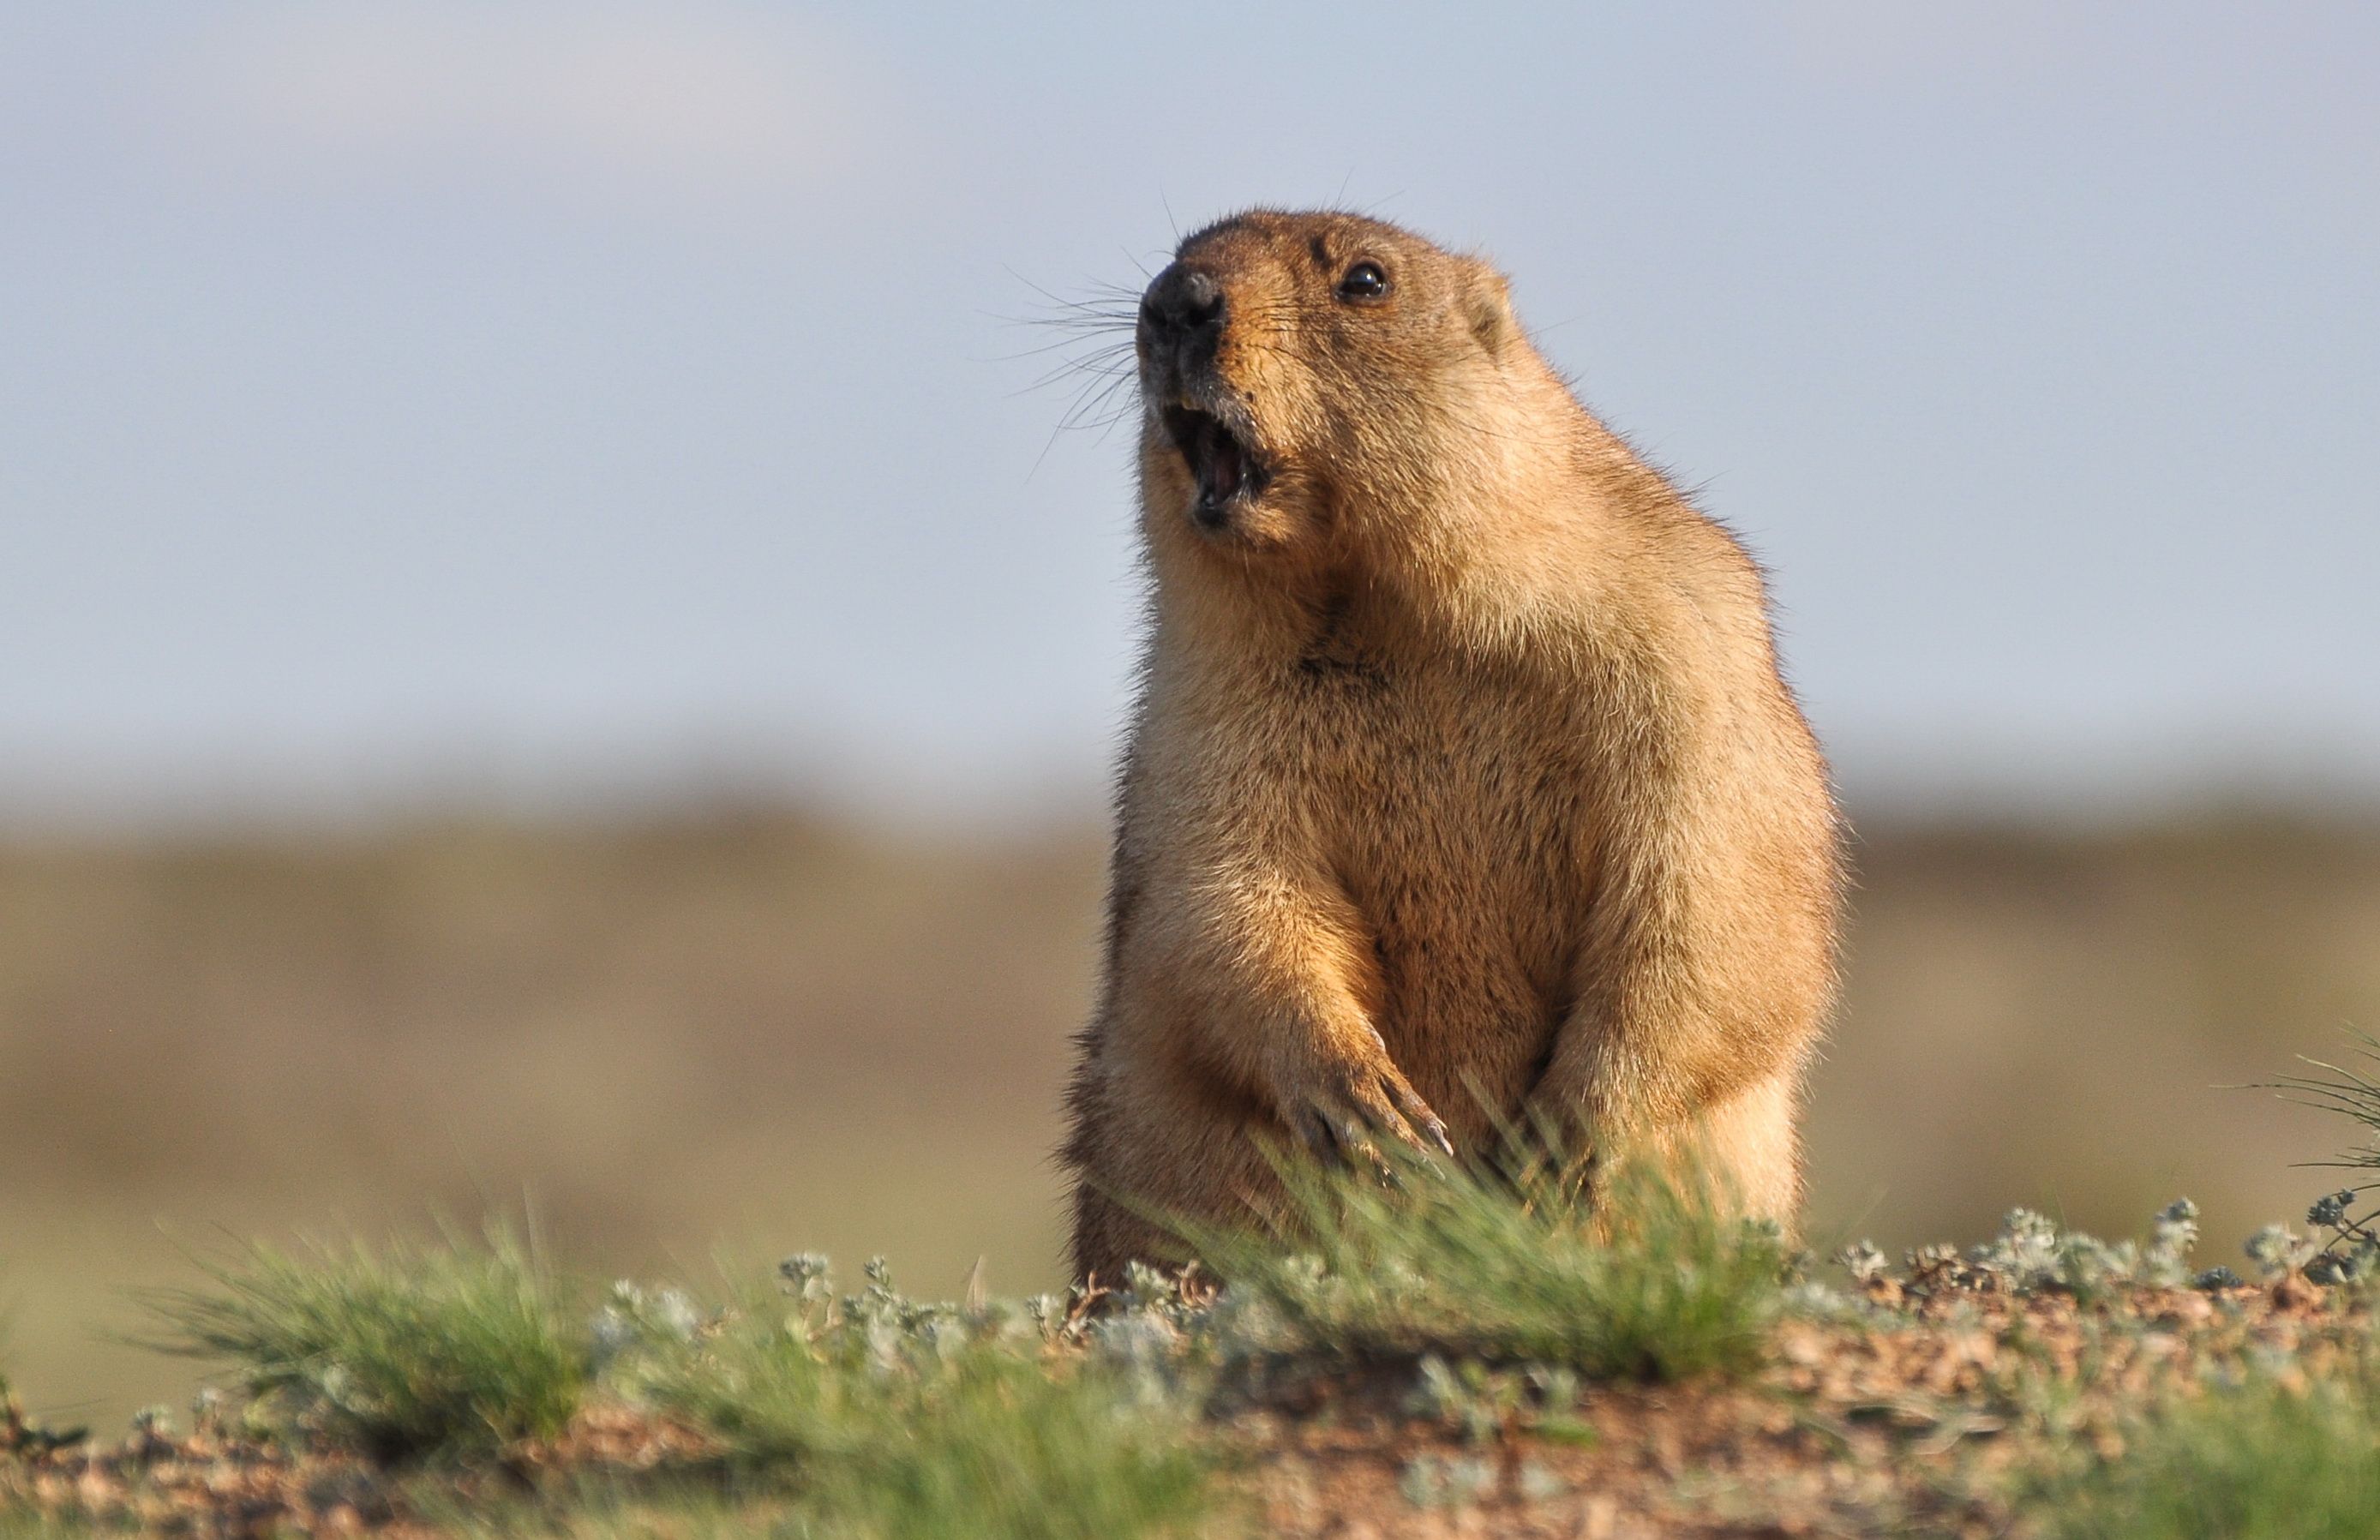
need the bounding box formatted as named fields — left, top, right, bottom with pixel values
left=1188, top=1152, right=1785, bottom=1381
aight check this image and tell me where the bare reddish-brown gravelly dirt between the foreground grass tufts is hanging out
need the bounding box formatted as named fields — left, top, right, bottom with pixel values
left=0, top=1273, right=2373, bottom=1540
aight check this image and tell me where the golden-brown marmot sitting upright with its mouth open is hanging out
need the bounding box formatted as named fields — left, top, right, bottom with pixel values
left=1064, top=209, right=1842, bottom=1278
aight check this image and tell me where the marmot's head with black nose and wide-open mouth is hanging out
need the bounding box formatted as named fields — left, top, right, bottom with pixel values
left=1136, top=209, right=1528, bottom=554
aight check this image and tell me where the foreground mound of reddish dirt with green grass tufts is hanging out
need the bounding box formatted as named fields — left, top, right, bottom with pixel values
left=0, top=1066, right=2380, bottom=1540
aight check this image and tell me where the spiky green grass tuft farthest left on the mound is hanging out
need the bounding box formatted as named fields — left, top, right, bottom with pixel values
left=147, top=1228, right=588, bottom=1459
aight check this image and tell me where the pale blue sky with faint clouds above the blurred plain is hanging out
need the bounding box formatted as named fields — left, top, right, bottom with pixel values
left=0, top=0, right=2380, bottom=818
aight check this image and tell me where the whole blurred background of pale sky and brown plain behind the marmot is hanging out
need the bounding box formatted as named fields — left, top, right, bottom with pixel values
left=0, top=0, right=2380, bottom=1418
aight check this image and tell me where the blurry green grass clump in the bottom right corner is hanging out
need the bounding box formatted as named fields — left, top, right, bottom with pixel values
left=2042, top=1375, right=2380, bottom=1540
